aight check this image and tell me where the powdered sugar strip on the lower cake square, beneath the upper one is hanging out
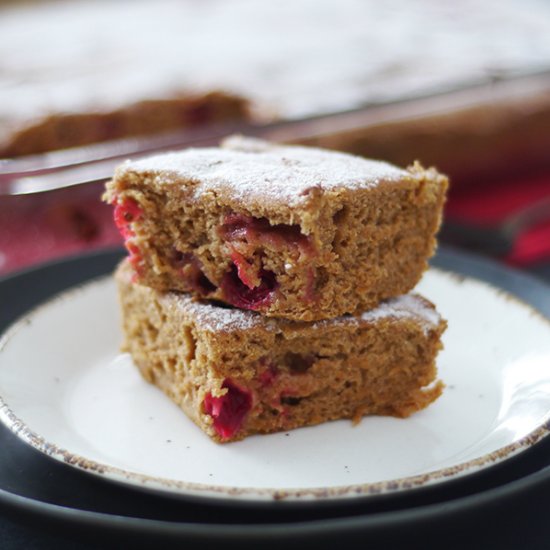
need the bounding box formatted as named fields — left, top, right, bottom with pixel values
left=161, top=293, right=441, bottom=333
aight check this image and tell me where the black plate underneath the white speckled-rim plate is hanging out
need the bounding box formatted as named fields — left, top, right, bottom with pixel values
left=0, top=250, right=550, bottom=547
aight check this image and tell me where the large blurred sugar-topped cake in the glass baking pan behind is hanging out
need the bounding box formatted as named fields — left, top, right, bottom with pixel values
left=4, top=0, right=550, bottom=163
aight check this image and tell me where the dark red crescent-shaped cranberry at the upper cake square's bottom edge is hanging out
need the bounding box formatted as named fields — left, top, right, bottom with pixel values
left=221, top=265, right=278, bottom=310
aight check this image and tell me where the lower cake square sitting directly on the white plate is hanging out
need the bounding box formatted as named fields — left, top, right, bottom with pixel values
left=116, top=262, right=446, bottom=442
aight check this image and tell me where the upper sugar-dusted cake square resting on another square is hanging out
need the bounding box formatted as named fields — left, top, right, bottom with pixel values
left=105, top=137, right=447, bottom=321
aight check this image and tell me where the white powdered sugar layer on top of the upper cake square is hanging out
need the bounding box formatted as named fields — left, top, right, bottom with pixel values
left=117, top=137, right=410, bottom=204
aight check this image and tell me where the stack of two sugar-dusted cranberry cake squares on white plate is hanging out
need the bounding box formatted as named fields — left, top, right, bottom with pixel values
left=105, top=136, right=448, bottom=442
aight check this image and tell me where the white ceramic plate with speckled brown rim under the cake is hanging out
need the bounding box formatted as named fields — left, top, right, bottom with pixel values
left=0, top=269, right=550, bottom=500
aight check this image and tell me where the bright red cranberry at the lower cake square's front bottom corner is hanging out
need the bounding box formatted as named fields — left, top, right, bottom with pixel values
left=203, top=379, right=252, bottom=439
